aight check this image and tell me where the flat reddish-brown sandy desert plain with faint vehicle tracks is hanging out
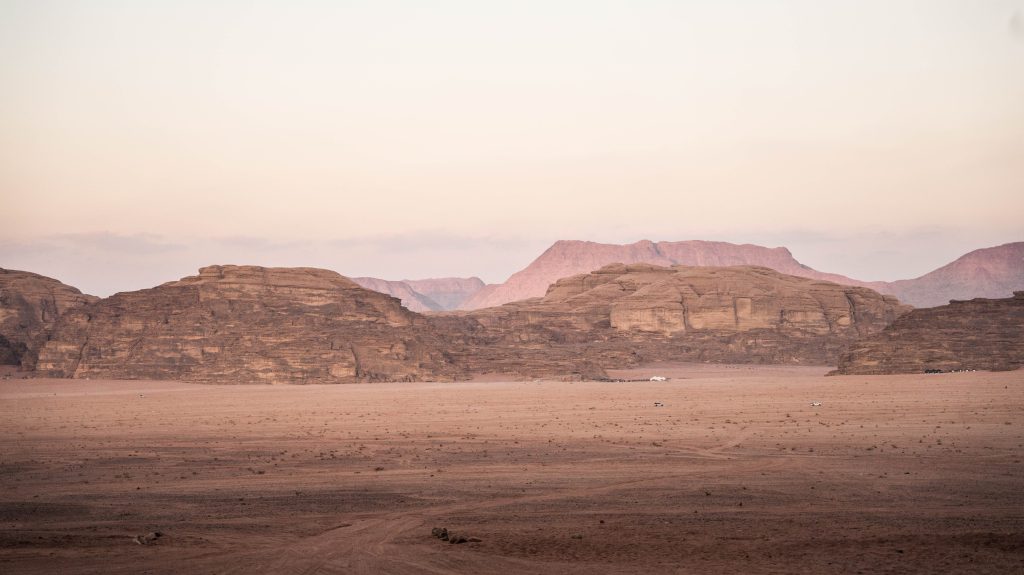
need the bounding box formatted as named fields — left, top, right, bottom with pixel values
left=0, top=365, right=1024, bottom=575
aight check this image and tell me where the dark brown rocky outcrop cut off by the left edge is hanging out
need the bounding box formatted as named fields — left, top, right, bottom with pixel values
left=0, top=268, right=97, bottom=369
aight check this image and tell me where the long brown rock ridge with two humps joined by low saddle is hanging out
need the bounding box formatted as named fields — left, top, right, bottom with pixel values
left=37, top=264, right=906, bottom=383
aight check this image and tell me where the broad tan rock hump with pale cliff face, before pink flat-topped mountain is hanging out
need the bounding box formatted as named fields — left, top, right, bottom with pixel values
left=444, top=264, right=909, bottom=378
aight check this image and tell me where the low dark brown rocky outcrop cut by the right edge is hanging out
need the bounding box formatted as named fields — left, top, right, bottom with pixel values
left=834, top=292, right=1024, bottom=374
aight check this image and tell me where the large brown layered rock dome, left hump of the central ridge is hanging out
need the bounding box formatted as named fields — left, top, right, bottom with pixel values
left=37, top=266, right=462, bottom=384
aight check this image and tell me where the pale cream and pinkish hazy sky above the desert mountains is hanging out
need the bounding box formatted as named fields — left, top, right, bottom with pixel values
left=0, top=0, right=1024, bottom=296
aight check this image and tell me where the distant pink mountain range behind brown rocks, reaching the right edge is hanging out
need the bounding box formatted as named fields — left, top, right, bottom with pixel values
left=461, top=240, right=1024, bottom=310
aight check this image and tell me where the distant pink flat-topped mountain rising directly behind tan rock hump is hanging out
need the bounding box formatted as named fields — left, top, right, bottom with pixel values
left=462, top=240, right=884, bottom=310
